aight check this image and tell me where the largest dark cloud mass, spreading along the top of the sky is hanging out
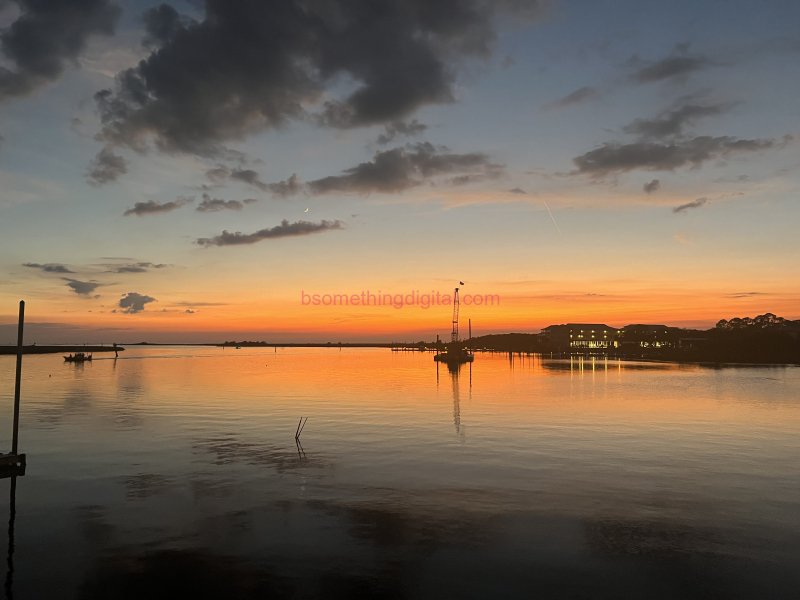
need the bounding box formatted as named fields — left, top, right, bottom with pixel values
left=95, top=0, right=541, bottom=155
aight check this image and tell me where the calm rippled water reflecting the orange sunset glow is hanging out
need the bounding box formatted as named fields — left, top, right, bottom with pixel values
left=0, top=348, right=800, bottom=599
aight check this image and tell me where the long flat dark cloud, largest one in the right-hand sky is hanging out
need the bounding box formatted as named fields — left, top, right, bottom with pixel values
left=573, top=136, right=779, bottom=178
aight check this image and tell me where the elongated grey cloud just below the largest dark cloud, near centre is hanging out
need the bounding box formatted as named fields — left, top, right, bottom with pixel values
left=308, top=142, right=503, bottom=194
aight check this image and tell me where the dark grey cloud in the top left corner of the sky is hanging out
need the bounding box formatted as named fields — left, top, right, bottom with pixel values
left=0, top=0, right=121, bottom=100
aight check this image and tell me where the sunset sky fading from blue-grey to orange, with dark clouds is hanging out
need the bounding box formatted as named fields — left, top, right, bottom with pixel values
left=0, top=0, right=800, bottom=344
